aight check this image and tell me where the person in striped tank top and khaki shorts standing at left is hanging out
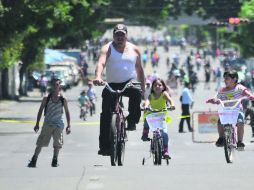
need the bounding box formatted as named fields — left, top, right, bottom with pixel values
left=28, top=79, right=71, bottom=168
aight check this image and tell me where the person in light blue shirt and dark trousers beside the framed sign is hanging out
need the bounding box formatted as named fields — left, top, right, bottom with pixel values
left=178, top=82, right=194, bottom=133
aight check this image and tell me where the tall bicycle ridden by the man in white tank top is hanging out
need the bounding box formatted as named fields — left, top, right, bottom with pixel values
left=105, top=81, right=141, bottom=166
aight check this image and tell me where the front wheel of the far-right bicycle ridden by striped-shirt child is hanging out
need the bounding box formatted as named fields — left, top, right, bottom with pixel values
left=224, top=124, right=234, bottom=163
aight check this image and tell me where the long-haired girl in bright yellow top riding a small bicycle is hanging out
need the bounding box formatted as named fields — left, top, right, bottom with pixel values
left=141, top=78, right=175, bottom=159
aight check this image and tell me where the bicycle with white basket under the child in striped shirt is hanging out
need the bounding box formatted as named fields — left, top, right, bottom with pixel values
left=218, top=99, right=242, bottom=163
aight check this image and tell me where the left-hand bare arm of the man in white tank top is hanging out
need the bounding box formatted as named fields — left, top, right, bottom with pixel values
left=94, top=43, right=110, bottom=85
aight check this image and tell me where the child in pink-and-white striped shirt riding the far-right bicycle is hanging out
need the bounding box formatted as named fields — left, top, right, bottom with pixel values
left=206, top=70, right=254, bottom=148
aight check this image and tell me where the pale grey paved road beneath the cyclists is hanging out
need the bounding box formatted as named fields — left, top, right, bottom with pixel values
left=0, top=45, right=254, bottom=190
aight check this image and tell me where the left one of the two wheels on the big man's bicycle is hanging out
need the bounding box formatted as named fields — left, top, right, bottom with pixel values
left=110, top=114, right=117, bottom=166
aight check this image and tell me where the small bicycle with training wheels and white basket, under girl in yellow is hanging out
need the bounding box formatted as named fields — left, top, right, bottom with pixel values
left=141, top=107, right=174, bottom=165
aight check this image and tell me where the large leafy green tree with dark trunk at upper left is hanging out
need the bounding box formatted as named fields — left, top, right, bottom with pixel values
left=0, top=0, right=107, bottom=94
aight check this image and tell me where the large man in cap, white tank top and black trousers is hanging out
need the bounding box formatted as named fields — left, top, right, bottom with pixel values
left=94, top=24, right=145, bottom=155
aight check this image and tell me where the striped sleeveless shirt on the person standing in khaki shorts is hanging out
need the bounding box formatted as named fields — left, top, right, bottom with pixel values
left=44, top=98, right=64, bottom=128
